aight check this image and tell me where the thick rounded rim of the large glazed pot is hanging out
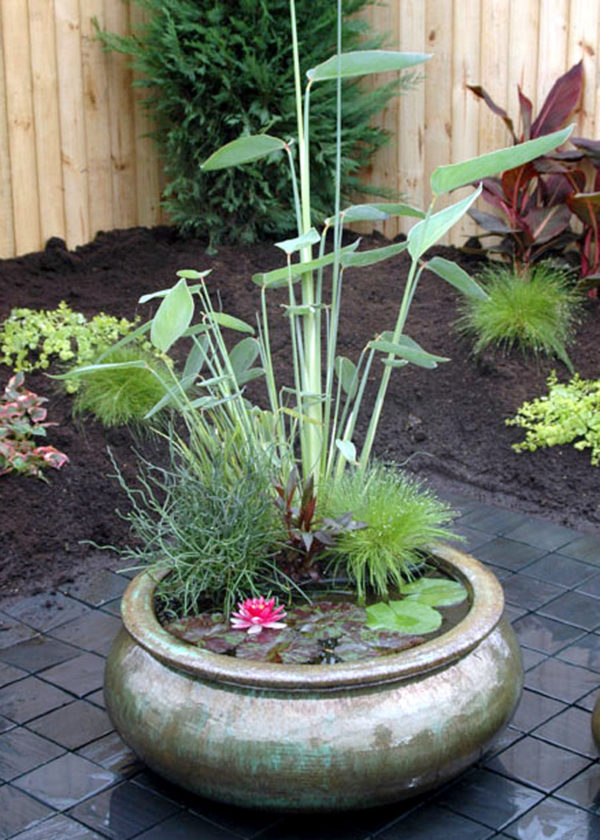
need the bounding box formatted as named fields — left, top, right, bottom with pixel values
left=121, top=544, right=504, bottom=691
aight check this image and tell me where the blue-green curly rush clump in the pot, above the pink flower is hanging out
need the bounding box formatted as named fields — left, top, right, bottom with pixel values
left=119, top=431, right=287, bottom=615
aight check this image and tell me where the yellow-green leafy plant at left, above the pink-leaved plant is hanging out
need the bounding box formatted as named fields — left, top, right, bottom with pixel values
left=0, top=301, right=134, bottom=393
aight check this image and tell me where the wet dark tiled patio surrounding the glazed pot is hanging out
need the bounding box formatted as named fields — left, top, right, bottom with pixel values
left=0, top=499, right=600, bottom=840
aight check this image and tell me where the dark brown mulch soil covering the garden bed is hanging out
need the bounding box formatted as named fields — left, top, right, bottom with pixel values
left=0, top=227, right=600, bottom=595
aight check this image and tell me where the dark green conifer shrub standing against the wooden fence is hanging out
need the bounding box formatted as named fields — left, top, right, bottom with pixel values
left=100, top=0, right=414, bottom=242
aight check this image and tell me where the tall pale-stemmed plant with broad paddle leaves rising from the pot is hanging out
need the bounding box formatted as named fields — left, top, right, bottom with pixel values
left=74, top=0, right=571, bottom=612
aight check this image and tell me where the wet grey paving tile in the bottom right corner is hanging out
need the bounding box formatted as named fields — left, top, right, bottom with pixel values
left=504, top=798, right=600, bottom=840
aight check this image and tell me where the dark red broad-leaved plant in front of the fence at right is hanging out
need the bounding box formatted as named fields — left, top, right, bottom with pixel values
left=468, top=61, right=600, bottom=286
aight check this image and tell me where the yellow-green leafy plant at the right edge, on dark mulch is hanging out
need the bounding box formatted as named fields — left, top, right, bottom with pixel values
left=505, top=371, right=600, bottom=467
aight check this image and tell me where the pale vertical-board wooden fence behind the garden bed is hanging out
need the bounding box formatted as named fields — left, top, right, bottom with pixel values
left=0, top=0, right=600, bottom=257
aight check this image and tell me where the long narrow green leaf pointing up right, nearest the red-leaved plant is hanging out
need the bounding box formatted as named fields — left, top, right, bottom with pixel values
left=431, top=125, right=573, bottom=195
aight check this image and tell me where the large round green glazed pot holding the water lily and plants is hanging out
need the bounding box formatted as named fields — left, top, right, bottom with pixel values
left=104, top=547, right=523, bottom=811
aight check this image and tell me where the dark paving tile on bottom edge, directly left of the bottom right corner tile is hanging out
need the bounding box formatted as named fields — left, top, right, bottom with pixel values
left=376, top=805, right=495, bottom=840
